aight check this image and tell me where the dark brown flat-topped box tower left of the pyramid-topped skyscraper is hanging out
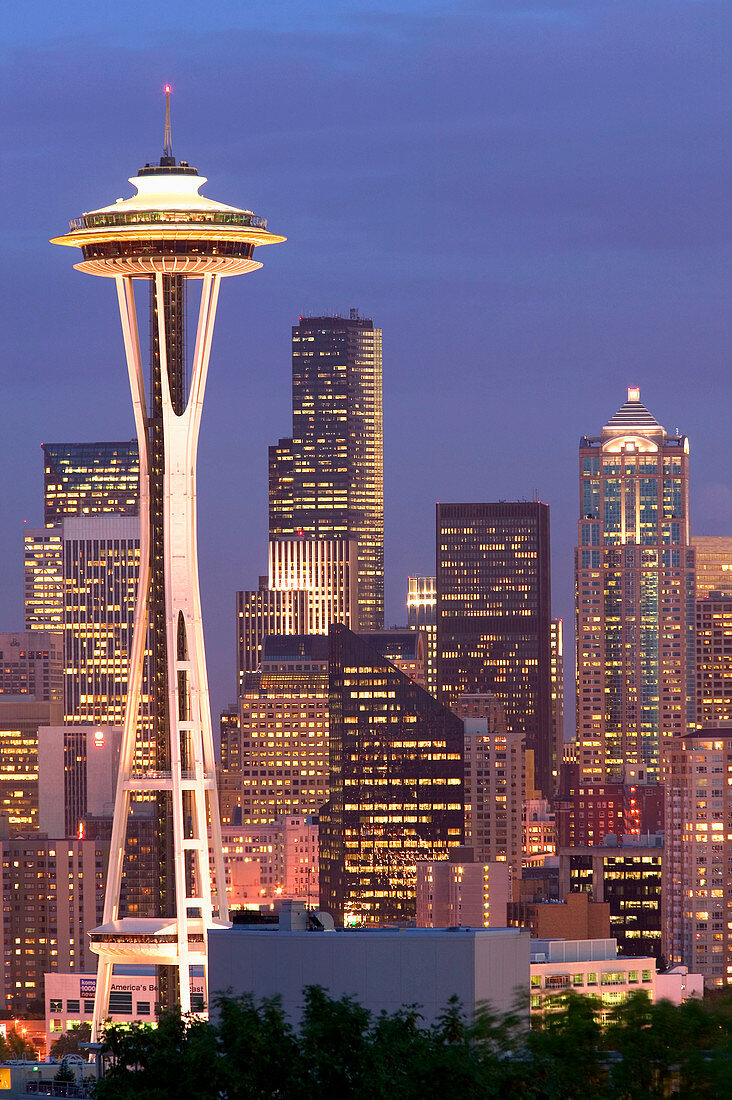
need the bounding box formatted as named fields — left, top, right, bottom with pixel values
left=437, top=502, right=555, bottom=795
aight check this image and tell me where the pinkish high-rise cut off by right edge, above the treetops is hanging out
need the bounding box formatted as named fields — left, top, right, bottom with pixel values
left=663, top=723, right=732, bottom=989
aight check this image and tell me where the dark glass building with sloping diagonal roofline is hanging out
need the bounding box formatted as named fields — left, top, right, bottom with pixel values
left=319, top=625, right=463, bottom=925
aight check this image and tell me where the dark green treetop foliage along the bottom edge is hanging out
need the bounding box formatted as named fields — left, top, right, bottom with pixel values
left=95, top=986, right=732, bottom=1100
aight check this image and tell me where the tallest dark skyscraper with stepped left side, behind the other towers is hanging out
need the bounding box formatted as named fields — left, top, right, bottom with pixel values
left=270, top=309, right=384, bottom=630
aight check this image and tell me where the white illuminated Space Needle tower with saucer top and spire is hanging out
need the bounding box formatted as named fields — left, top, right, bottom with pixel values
left=52, top=88, right=285, bottom=1038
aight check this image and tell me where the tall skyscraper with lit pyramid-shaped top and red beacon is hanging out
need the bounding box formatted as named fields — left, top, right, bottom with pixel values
left=575, top=387, right=696, bottom=782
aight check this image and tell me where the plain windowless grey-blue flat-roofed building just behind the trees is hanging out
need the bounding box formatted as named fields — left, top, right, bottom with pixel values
left=208, top=909, right=529, bottom=1025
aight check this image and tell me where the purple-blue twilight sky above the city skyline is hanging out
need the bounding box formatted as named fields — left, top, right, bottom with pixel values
left=0, top=0, right=732, bottom=724
